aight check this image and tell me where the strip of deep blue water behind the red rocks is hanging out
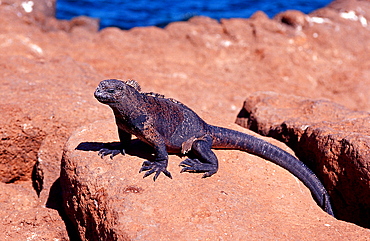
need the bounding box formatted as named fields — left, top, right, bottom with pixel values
left=57, top=0, right=331, bottom=29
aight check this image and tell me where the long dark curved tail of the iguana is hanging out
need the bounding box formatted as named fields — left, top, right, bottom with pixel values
left=211, top=126, right=334, bottom=216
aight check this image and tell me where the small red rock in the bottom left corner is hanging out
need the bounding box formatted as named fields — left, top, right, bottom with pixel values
left=0, top=182, right=69, bottom=241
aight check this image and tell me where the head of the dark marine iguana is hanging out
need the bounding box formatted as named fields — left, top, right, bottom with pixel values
left=94, top=79, right=140, bottom=104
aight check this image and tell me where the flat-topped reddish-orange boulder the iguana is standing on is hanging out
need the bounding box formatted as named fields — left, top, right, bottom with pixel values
left=61, top=119, right=369, bottom=240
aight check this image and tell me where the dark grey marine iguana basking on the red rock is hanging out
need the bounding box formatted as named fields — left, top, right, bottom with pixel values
left=94, top=79, right=334, bottom=216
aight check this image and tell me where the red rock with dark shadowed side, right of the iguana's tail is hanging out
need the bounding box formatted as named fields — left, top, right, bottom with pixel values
left=237, top=92, right=370, bottom=228
